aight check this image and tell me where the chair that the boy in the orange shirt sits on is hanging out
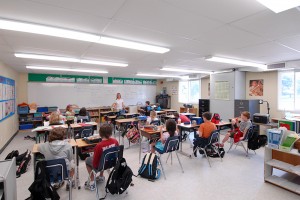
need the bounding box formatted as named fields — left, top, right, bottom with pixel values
left=193, top=130, right=223, bottom=167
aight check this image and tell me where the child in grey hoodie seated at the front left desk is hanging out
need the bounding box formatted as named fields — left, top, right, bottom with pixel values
left=38, top=127, right=75, bottom=190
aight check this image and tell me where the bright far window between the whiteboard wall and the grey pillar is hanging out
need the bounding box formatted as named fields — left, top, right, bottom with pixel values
left=178, top=80, right=200, bottom=103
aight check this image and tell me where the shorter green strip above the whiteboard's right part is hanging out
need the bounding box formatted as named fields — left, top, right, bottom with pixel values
left=108, top=77, right=157, bottom=85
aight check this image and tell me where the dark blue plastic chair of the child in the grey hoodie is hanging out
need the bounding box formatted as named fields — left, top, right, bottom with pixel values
left=46, top=158, right=72, bottom=200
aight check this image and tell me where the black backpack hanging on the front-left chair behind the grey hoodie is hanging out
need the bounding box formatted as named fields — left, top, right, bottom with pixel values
left=26, top=161, right=60, bottom=200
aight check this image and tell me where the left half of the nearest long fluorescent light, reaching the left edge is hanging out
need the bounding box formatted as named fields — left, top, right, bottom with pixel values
left=0, top=19, right=100, bottom=42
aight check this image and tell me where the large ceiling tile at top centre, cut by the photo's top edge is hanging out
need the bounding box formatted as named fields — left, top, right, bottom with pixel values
left=116, top=0, right=222, bottom=37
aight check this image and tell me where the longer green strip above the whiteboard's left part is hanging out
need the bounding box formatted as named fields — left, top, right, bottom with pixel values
left=28, top=73, right=103, bottom=84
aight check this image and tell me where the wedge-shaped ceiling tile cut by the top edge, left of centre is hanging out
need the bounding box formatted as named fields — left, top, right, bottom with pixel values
left=27, top=0, right=125, bottom=18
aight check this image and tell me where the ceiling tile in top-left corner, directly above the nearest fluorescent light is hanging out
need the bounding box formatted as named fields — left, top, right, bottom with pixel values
left=0, top=0, right=109, bottom=34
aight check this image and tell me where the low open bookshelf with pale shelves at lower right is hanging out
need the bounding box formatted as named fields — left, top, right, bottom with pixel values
left=264, top=146, right=300, bottom=195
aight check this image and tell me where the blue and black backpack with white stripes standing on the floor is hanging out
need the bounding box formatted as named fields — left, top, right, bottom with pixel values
left=138, top=153, right=160, bottom=180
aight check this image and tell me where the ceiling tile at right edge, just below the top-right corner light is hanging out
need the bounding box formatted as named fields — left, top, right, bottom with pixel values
left=232, top=9, right=300, bottom=40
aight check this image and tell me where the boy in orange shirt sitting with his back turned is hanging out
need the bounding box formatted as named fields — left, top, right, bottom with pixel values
left=193, top=112, right=217, bottom=157
